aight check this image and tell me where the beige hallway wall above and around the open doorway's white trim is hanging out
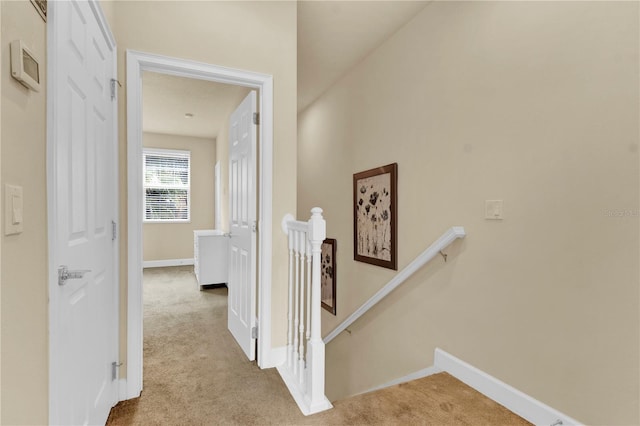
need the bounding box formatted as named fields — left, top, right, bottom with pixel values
left=112, top=1, right=297, bottom=374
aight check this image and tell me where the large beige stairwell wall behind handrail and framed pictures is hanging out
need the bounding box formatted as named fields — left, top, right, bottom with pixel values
left=298, top=2, right=640, bottom=424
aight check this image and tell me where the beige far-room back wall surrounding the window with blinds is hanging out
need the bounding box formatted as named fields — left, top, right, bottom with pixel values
left=142, top=133, right=216, bottom=261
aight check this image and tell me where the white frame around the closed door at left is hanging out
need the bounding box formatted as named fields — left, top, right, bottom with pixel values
left=46, top=0, right=122, bottom=424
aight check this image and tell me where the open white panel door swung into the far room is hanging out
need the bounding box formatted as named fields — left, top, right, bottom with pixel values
left=228, top=91, right=257, bottom=361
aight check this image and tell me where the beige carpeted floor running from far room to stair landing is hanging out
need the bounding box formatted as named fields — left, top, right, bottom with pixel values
left=107, top=267, right=528, bottom=425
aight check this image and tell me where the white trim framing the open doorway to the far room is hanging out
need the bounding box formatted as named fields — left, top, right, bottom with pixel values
left=125, top=50, right=277, bottom=399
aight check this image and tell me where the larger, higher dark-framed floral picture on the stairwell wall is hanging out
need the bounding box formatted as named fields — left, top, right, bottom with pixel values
left=353, top=163, right=398, bottom=270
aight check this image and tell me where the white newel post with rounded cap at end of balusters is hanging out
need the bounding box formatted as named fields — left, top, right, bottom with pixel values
left=307, top=207, right=327, bottom=411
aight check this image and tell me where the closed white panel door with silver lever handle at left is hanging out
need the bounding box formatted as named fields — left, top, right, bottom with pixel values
left=48, top=0, right=118, bottom=425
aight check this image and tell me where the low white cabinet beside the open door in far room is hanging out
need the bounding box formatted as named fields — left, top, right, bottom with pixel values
left=193, top=229, right=229, bottom=286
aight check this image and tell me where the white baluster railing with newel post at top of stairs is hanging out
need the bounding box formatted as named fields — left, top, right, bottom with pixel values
left=278, top=207, right=332, bottom=415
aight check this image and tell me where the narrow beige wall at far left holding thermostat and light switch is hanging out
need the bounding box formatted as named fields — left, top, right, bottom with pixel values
left=0, top=1, right=49, bottom=424
